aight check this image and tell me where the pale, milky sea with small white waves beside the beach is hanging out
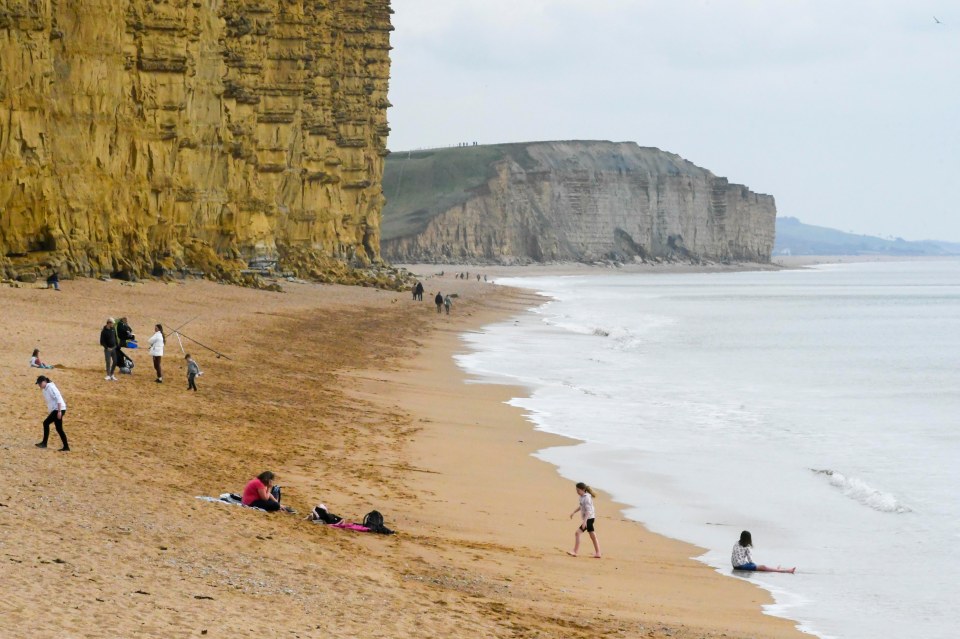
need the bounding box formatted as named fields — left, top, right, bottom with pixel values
left=458, top=259, right=960, bottom=639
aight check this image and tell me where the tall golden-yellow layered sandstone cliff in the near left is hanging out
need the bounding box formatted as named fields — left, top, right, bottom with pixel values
left=0, top=0, right=392, bottom=275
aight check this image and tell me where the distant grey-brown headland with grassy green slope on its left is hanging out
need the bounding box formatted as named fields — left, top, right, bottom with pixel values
left=381, top=142, right=776, bottom=262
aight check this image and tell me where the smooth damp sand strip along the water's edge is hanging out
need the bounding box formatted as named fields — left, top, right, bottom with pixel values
left=368, top=272, right=809, bottom=637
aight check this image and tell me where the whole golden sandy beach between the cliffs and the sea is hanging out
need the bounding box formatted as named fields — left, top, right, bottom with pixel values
left=0, top=266, right=801, bottom=638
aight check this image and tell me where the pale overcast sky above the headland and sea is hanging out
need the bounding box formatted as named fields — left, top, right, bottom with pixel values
left=388, top=0, right=960, bottom=241
